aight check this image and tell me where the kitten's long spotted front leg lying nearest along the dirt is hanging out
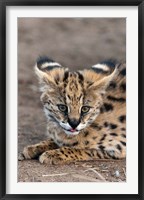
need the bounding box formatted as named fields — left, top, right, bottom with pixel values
left=39, top=147, right=123, bottom=164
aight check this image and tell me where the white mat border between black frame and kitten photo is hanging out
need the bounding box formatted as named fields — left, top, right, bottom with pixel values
left=6, top=6, right=138, bottom=194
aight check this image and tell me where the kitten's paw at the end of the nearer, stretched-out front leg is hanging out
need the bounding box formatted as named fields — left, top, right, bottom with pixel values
left=39, top=150, right=66, bottom=165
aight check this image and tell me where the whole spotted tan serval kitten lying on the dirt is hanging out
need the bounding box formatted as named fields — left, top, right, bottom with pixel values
left=23, top=57, right=126, bottom=164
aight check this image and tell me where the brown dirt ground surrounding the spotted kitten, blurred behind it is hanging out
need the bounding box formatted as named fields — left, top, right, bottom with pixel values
left=18, top=18, right=126, bottom=182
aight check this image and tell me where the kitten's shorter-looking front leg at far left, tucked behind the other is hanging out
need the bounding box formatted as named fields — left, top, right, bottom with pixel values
left=19, top=140, right=58, bottom=160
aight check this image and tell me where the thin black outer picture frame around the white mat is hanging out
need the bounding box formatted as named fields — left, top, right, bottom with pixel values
left=0, top=0, right=144, bottom=200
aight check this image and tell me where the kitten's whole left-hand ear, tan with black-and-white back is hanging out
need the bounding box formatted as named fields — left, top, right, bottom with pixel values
left=35, top=57, right=66, bottom=90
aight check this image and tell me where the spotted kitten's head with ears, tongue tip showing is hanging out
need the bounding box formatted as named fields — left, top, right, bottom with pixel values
left=35, top=57, right=116, bottom=135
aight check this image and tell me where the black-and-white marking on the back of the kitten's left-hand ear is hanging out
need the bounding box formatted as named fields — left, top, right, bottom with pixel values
left=36, top=56, right=62, bottom=71
